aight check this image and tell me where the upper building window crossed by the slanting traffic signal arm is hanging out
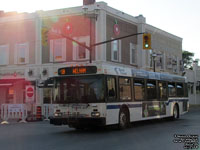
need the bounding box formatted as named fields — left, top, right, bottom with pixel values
left=73, top=36, right=90, bottom=60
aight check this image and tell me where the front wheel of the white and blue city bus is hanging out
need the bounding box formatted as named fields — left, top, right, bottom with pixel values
left=119, top=109, right=130, bottom=129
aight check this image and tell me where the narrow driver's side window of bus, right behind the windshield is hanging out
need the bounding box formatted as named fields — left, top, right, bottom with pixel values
left=107, top=77, right=116, bottom=100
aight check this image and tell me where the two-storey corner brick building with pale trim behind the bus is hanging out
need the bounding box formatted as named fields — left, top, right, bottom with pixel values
left=0, top=2, right=182, bottom=115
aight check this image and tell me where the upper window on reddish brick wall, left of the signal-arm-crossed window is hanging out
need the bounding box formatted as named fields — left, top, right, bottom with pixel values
left=50, top=38, right=66, bottom=62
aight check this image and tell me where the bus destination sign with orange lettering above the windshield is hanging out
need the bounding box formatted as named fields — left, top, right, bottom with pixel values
left=58, top=66, right=97, bottom=75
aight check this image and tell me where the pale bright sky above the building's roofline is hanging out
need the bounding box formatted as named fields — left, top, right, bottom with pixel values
left=0, top=0, right=200, bottom=59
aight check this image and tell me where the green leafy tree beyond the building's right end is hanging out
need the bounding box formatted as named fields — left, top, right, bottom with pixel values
left=182, top=51, right=194, bottom=69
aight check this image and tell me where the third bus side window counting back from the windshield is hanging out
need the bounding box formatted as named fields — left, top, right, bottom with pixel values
left=134, top=79, right=144, bottom=101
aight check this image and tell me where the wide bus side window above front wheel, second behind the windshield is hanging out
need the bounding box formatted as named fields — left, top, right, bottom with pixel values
left=119, top=78, right=131, bottom=100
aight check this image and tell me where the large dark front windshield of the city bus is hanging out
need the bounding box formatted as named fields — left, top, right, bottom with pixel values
left=53, top=75, right=104, bottom=104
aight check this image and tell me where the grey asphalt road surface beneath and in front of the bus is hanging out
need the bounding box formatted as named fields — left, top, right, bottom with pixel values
left=0, top=107, right=200, bottom=150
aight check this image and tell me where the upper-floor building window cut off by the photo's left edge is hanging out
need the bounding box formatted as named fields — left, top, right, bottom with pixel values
left=0, top=45, right=9, bottom=65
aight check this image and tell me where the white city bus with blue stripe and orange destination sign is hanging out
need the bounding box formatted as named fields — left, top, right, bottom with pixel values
left=49, top=63, right=189, bottom=129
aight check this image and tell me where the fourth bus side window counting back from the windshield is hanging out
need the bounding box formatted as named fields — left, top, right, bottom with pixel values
left=147, top=80, right=157, bottom=100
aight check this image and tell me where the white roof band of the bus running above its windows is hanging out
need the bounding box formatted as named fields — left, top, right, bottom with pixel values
left=52, top=63, right=186, bottom=82
